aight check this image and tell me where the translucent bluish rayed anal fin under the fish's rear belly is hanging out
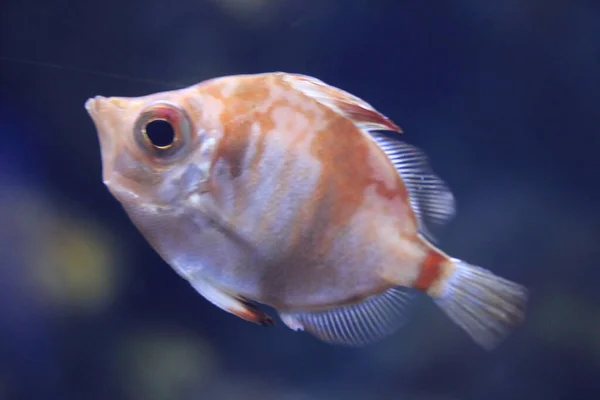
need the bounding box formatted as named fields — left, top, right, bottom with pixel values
left=280, top=287, right=415, bottom=347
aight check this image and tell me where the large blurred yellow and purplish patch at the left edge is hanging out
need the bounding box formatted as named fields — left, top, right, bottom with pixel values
left=2, top=187, right=123, bottom=313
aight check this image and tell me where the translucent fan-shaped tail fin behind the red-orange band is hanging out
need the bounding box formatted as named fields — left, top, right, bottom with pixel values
left=435, top=259, right=527, bottom=350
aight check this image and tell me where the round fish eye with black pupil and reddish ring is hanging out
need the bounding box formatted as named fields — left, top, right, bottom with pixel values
left=134, top=102, right=192, bottom=162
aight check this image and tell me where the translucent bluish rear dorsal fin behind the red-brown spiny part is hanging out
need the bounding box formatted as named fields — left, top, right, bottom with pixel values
left=370, top=132, right=455, bottom=240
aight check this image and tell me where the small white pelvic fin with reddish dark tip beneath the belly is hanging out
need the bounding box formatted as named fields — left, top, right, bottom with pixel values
left=190, top=279, right=275, bottom=326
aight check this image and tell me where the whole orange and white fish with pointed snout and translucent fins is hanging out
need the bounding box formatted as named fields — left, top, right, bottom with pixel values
left=85, top=72, right=528, bottom=350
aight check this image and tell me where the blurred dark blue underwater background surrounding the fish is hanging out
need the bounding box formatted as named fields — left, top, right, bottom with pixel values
left=0, top=0, right=600, bottom=400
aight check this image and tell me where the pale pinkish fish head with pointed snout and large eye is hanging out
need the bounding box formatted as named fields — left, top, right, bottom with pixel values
left=85, top=86, right=220, bottom=211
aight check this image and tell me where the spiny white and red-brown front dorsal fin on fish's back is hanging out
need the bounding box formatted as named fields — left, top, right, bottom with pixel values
left=282, top=74, right=402, bottom=133
